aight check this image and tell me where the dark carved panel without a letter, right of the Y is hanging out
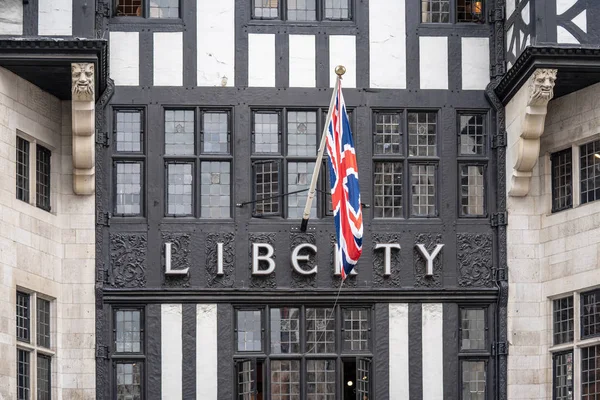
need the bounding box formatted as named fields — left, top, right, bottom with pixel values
left=456, top=233, right=493, bottom=287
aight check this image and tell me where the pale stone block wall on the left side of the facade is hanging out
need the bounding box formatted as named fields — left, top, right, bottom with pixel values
left=0, top=68, right=95, bottom=399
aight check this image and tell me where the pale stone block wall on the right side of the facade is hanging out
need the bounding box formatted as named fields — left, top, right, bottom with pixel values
left=506, top=80, right=600, bottom=399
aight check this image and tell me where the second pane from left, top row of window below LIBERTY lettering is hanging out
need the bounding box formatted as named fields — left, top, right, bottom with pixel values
left=271, top=307, right=300, bottom=354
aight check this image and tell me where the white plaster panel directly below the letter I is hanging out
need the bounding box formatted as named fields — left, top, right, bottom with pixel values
left=196, top=304, right=218, bottom=400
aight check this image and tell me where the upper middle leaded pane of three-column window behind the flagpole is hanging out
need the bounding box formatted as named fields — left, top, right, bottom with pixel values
left=287, top=111, right=317, bottom=156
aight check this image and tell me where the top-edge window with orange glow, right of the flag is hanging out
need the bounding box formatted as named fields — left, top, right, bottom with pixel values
left=421, top=0, right=485, bottom=23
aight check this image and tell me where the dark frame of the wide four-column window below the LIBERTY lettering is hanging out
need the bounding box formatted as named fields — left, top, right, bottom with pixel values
left=232, top=304, right=375, bottom=399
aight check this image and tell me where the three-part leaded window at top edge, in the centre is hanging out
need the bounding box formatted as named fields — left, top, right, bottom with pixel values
left=252, top=0, right=352, bottom=22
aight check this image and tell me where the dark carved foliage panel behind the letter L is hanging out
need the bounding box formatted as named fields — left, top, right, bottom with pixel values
left=161, top=232, right=192, bottom=287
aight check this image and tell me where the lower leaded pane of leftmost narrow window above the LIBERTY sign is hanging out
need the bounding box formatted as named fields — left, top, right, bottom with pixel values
left=115, top=162, right=142, bottom=215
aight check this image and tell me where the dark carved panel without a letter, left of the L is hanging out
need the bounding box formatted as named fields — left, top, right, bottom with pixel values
left=109, top=233, right=148, bottom=288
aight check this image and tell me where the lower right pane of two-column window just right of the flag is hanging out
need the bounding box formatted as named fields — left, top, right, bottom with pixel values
left=410, top=165, right=436, bottom=217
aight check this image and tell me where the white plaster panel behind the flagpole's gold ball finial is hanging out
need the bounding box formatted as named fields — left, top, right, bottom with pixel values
left=329, top=35, right=356, bottom=88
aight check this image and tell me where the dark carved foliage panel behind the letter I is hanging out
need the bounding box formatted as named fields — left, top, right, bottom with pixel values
left=206, top=232, right=235, bottom=287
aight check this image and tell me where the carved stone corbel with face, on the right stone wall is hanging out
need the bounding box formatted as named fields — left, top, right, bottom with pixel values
left=508, top=69, right=558, bottom=197
